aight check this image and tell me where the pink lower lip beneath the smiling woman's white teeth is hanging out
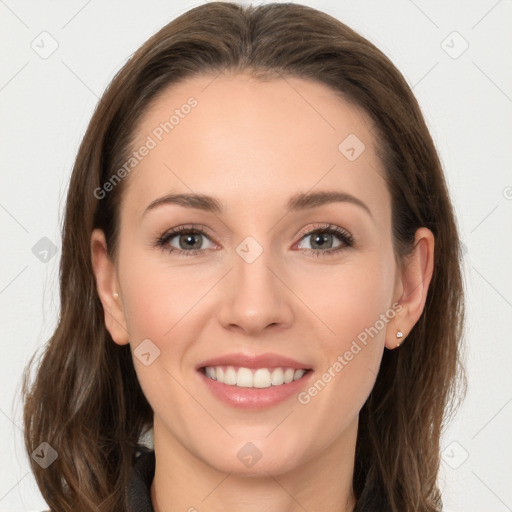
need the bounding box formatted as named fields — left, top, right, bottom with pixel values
left=198, top=370, right=313, bottom=409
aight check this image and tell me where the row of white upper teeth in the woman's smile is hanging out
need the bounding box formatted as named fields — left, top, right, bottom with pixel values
left=205, top=366, right=306, bottom=388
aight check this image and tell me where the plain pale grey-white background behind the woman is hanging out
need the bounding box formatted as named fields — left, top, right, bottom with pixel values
left=0, top=0, right=512, bottom=512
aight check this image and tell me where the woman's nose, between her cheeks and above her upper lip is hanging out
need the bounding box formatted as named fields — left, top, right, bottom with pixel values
left=218, top=244, right=294, bottom=335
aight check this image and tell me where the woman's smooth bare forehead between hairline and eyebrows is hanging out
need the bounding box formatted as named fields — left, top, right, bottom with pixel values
left=123, top=74, right=389, bottom=222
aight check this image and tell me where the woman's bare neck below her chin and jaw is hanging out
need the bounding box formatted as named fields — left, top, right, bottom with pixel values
left=151, top=415, right=357, bottom=512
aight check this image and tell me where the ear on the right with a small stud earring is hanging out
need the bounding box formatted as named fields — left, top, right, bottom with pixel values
left=386, top=227, right=434, bottom=349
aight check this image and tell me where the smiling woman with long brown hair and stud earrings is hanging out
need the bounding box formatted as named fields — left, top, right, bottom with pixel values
left=24, top=2, right=463, bottom=512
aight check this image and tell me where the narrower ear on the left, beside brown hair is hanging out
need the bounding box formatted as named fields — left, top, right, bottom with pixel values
left=91, top=229, right=129, bottom=345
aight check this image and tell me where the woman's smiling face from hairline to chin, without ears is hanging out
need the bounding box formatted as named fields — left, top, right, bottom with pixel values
left=98, top=75, right=402, bottom=474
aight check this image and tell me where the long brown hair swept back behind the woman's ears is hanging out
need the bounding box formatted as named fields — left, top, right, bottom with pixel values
left=23, top=2, right=466, bottom=512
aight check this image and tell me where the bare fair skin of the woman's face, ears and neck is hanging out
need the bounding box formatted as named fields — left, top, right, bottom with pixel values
left=91, top=74, right=434, bottom=512
